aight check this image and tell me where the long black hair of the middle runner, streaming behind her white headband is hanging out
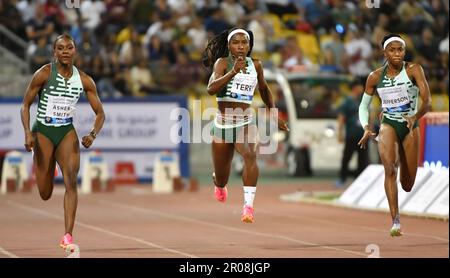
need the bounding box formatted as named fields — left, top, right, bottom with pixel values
left=202, top=28, right=253, bottom=69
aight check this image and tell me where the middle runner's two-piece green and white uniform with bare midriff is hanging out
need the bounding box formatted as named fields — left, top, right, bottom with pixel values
left=211, top=56, right=258, bottom=143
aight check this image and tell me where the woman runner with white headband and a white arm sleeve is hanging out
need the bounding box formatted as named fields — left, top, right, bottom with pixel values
left=358, top=34, right=431, bottom=236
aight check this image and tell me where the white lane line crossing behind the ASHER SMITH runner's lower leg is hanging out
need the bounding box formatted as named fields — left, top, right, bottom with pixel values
left=7, top=201, right=198, bottom=258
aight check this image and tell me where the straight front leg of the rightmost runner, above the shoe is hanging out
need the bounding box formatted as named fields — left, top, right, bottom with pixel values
left=378, top=124, right=398, bottom=220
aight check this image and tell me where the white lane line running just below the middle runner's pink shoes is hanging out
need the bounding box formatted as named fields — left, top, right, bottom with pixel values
left=99, top=201, right=368, bottom=257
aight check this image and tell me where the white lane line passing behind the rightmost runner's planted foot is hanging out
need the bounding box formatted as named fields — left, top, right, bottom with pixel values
left=258, top=207, right=449, bottom=243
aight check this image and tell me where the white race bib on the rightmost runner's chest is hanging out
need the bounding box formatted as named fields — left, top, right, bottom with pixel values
left=377, top=85, right=410, bottom=112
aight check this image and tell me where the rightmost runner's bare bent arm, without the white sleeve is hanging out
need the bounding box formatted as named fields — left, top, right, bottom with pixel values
left=404, top=63, right=431, bottom=129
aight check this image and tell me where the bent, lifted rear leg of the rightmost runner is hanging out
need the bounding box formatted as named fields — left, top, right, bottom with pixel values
left=399, top=128, right=420, bottom=192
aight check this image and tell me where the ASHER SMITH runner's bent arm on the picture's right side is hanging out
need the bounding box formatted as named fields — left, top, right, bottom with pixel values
left=80, top=72, right=105, bottom=148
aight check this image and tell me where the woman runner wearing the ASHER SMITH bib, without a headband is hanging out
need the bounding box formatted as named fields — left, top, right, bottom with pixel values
left=21, top=35, right=105, bottom=249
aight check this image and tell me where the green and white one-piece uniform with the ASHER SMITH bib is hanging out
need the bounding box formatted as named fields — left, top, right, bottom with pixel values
left=32, top=63, right=84, bottom=146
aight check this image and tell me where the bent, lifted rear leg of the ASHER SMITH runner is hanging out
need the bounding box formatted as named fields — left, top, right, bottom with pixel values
left=33, top=132, right=56, bottom=201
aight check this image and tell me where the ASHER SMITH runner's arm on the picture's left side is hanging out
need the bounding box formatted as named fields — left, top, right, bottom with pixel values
left=20, top=64, right=50, bottom=151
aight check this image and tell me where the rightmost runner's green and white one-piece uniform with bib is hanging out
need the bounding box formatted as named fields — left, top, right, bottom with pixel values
left=377, top=62, right=419, bottom=142
